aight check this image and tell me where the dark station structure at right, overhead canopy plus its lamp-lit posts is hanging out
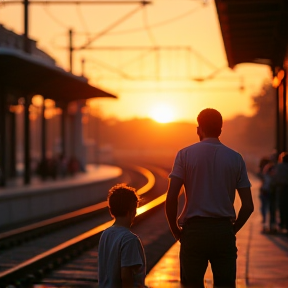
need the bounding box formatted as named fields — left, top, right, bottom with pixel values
left=215, top=0, right=288, bottom=154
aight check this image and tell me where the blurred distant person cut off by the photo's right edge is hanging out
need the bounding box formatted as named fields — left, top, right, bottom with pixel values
left=274, top=152, right=288, bottom=233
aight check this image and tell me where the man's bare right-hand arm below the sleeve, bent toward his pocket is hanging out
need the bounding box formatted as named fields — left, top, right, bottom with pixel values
left=233, top=187, right=254, bottom=234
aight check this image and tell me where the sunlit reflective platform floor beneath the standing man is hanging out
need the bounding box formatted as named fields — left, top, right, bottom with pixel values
left=146, top=175, right=288, bottom=288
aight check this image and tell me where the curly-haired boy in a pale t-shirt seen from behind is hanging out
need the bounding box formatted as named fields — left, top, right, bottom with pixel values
left=98, top=184, right=146, bottom=288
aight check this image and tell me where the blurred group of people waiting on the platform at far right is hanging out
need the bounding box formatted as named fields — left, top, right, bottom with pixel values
left=258, top=152, right=288, bottom=235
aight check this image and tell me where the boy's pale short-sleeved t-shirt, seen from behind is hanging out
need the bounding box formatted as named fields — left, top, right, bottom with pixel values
left=98, top=226, right=146, bottom=288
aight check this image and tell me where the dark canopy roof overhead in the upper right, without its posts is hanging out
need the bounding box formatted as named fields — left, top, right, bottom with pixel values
left=215, top=0, right=288, bottom=68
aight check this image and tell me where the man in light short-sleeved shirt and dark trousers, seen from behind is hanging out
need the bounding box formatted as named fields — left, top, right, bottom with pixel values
left=165, top=108, right=254, bottom=288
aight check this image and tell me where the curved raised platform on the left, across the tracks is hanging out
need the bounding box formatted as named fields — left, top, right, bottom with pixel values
left=0, top=165, right=122, bottom=232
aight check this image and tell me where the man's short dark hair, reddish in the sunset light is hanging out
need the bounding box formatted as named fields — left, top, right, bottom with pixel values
left=197, top=108, right=223, bottom=137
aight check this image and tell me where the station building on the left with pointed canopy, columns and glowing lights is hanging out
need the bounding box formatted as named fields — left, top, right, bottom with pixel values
left=0, top=24, right=117, bottom=186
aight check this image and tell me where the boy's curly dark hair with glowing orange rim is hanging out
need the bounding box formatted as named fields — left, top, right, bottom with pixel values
left=107, top=183, right=139, bottom=217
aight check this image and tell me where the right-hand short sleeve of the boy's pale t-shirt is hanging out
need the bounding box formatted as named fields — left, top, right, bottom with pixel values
left=121, top=237, right=144, bottom=267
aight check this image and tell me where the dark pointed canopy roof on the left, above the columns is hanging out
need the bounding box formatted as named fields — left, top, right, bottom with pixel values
left=0, top=48, right=117, bottom=103
